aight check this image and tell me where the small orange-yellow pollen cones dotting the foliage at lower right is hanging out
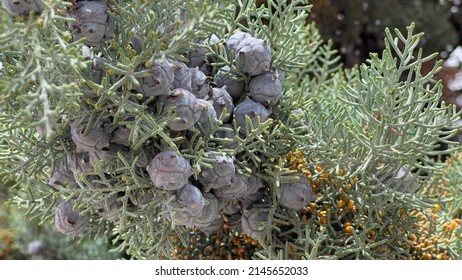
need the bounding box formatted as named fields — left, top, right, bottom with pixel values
left=287, top=150, right=462, bottom=260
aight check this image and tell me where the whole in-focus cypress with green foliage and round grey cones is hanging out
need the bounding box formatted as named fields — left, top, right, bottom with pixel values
left=0, top=0, right=460, bottom=259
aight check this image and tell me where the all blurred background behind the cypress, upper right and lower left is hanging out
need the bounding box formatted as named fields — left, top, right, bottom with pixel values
left=0, top=0, right=462, bottom=259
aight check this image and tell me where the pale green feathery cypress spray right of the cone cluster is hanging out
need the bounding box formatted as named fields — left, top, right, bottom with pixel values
left=257, top=21, right=459, bottom=259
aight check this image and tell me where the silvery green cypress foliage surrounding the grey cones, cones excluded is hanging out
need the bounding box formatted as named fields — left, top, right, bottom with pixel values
left=0, top=0, right=460, bottom=259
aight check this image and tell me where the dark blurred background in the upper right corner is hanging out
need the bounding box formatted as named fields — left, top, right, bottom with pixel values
left=310, top=0, right=462, bottom=67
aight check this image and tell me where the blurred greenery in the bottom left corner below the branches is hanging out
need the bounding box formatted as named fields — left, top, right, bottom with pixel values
left=0, top=182, right=122, bottom=260
